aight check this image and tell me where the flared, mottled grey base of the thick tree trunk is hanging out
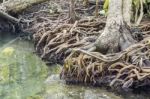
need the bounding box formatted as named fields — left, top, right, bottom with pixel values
left=95, top=22, right=136, bottom=54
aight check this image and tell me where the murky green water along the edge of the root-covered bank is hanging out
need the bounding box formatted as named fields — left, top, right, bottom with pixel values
left=0, top=37, right=148, bottom=99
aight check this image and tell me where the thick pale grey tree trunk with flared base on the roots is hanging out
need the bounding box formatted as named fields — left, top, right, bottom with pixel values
left=95, top=0, right=135, bottom=54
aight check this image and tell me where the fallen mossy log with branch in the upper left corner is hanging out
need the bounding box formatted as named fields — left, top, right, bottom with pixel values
left=0, top=0, right=47, bottom=23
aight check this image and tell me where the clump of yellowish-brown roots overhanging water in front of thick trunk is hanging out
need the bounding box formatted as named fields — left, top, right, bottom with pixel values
left=61, top=37, right=150, bottom=89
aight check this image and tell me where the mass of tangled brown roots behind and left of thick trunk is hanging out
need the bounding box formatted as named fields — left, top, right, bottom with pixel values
left=20, top=0, right=106, bottom=64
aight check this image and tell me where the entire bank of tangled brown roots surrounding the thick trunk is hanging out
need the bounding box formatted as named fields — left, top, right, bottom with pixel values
left=1, top=0, right=150, bottom=94
